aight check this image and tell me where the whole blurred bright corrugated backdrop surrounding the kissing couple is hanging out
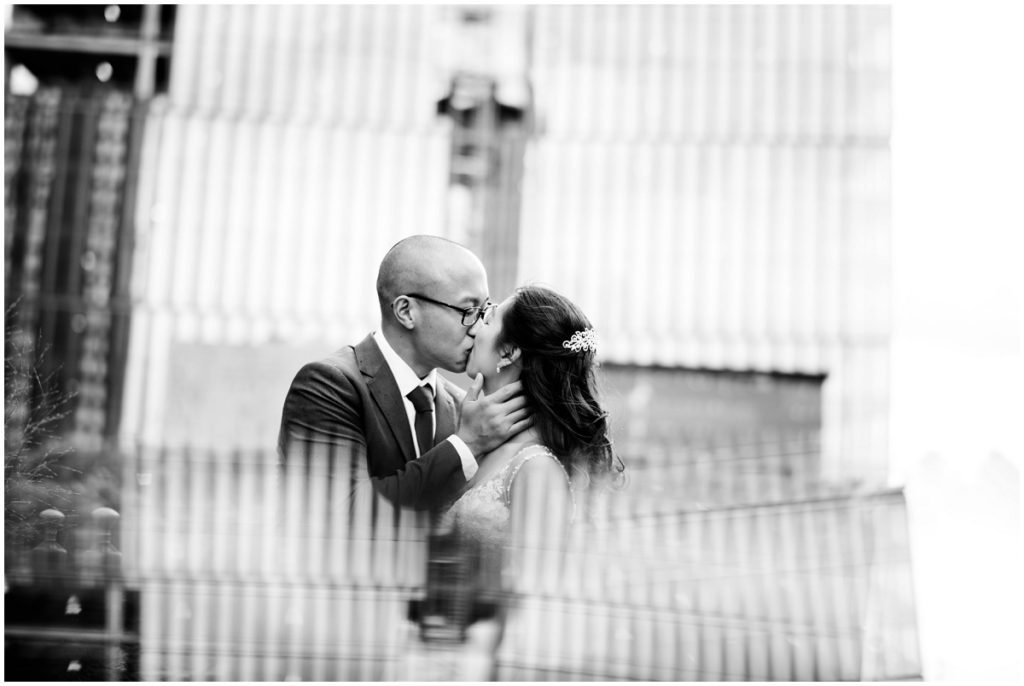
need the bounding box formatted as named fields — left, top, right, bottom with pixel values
left=4, top=3, right=1024, bottom=681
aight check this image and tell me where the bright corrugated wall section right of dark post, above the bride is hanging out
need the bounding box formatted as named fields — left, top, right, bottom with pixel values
left=519, top=5, right=890, bottom=481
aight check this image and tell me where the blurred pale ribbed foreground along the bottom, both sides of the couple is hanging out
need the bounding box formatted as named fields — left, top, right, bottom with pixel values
left=8, top=438, right=921, bottom=681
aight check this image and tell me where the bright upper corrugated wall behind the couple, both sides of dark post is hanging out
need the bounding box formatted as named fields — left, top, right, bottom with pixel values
left=117, top=5, right=890, bottom=481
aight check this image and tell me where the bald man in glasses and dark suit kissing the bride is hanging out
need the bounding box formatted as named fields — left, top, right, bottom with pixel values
left=279, top=235, right=531, bottom=510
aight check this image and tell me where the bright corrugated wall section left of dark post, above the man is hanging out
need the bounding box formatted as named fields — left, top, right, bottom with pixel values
left=123, top=5, right=450, bottom=442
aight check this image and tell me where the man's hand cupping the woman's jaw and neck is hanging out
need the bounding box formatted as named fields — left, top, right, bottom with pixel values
left=456, top=374, right=534, bottom=459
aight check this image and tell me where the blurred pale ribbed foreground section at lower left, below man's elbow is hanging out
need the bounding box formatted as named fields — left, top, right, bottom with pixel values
left=125, top=449, right=426, bottom=681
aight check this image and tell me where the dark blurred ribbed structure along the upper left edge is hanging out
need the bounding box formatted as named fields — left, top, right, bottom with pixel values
left=4, top=5, right=174, bottom=452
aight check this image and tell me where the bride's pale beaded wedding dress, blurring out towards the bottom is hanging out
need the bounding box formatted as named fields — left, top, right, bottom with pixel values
left=410, top=444, right=577, bottom=681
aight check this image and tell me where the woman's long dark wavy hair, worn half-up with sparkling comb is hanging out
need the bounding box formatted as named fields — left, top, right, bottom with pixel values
left=497, top=286, right=624, bottom=484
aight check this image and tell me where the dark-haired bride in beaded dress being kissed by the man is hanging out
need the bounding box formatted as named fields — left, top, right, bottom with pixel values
left=421, top=286, right=623, bottom=675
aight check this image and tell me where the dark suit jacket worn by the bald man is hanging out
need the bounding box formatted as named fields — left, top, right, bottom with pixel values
left=278, top=335, right=466, bottom=510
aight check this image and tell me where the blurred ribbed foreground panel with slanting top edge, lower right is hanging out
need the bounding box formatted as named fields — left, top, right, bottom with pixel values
left=499, top=490, right=920, bottom=681
